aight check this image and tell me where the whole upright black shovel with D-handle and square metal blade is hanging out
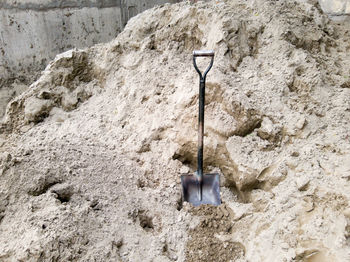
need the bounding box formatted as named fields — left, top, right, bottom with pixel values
left=181, top=50, right=221, bottom=206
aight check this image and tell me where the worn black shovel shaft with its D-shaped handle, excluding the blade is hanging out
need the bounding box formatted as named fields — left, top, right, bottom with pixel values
left=193, top=51, right=214, bottom=198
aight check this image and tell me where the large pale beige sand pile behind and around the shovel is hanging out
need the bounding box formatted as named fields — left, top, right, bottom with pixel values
left=0, top=1, right=350, bottom=261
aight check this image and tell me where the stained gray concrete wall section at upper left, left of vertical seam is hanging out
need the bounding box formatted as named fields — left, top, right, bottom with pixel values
left=0, top=5, right=122, bottom=81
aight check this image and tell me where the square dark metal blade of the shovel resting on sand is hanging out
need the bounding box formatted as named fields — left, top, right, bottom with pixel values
left=181, top=174, right=221, bottom=206
